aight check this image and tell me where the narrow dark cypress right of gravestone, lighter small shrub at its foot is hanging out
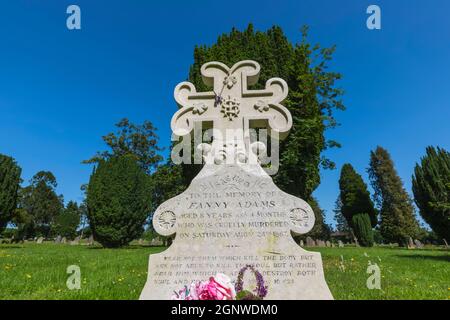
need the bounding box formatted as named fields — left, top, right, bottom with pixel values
left=339, top=163, right=377, bottom=246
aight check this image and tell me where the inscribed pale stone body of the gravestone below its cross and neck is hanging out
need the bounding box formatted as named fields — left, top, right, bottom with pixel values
left=141, top=166, right=332, bottom=299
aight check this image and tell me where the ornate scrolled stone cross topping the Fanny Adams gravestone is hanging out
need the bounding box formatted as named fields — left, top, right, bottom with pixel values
left=171, top=60, right=292, bottom=165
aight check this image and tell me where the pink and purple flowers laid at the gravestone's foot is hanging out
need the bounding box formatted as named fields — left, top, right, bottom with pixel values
left=172, top=265, right=267, bottom=300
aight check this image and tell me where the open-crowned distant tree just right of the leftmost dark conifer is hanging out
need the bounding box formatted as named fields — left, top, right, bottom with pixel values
left=19, top=171, right=64, bottom=237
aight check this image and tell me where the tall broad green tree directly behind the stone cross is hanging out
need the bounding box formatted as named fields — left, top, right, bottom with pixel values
left=182, top=24, right=345, bottom=231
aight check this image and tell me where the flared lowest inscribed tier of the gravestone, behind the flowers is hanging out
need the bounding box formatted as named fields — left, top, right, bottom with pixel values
left=140, top=245, right=333, bottom=300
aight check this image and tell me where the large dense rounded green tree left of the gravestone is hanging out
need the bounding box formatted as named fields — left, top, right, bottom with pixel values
left=86, top=155, right=151, bottom=247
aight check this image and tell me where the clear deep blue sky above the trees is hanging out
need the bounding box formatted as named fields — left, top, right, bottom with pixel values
left=0, top=0, right=450, bottom=226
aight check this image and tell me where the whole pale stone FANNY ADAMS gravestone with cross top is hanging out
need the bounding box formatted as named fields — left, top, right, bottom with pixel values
left=140, top=60, right=333, bottom=300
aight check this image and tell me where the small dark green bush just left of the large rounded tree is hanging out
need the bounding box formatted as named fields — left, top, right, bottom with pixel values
left=53, top=201, right=81, bottom=239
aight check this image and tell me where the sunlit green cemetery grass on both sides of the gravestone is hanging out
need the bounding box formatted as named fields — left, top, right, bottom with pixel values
left=0, top=243, right=450, bottom=299
